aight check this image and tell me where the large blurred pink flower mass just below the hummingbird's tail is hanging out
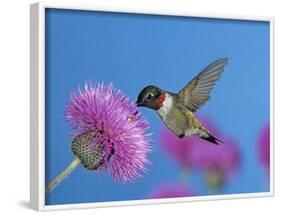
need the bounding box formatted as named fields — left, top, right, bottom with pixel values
left=161, top=117, right=240, bottom=178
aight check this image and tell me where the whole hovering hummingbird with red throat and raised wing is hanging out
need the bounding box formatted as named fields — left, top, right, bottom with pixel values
left=136, top=58, right=228, bottom=145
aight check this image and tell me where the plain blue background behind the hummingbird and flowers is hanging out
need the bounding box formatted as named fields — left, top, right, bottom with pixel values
left=46, top=9, right=270, bottom=204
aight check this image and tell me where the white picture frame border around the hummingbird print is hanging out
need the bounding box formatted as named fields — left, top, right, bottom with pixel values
left=30, top=2, right=274, bottom=211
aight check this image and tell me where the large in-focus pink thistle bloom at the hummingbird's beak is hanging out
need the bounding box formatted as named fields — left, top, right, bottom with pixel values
left=65, top=82, right=150, bottom=183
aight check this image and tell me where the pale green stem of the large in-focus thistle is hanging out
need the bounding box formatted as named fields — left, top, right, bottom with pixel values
left=45, top=157, right=81, bottom=194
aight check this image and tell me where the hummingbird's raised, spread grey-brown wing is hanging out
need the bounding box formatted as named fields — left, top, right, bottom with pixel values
left=178, top=58, right=228, bottom=112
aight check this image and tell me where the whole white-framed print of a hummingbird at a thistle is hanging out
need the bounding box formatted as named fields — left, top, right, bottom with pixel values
left=30, top=3, right=273, bottom=210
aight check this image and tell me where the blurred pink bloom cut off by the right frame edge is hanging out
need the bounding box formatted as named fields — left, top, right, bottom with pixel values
left=258, top=123, right=270, bottom=174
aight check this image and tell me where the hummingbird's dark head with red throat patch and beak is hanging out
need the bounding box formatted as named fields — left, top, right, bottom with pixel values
left=136, top=86, right=165, bottom=110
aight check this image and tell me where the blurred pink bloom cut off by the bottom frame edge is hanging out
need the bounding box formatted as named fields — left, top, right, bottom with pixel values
left=149, top=183, right=194, bottom=198
